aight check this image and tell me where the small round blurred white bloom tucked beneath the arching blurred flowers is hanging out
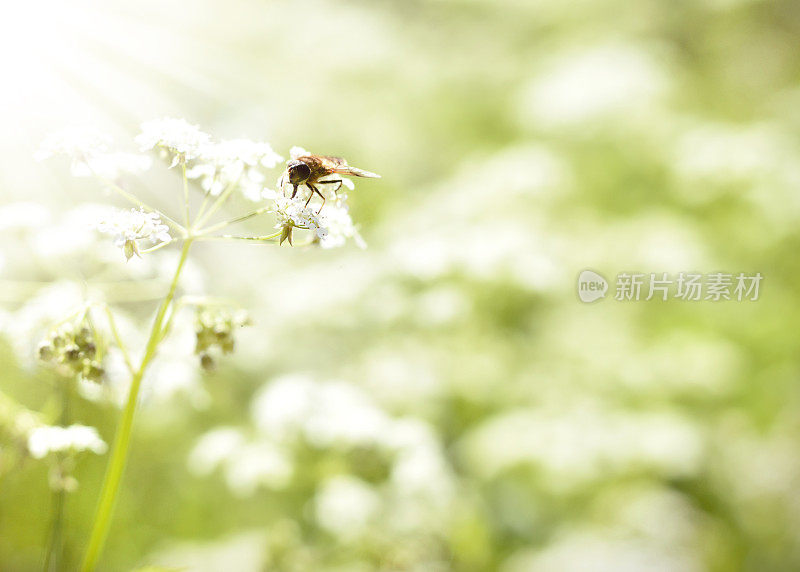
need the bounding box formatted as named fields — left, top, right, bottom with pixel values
left=314, top=475, right=381, bottom=539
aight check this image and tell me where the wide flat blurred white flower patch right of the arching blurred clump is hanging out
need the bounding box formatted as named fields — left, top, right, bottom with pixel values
left=461, top=406, right=703, bottom=489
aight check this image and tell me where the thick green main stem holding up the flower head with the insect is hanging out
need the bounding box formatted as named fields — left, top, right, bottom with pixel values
left=81, top=238, right=192, bottom=572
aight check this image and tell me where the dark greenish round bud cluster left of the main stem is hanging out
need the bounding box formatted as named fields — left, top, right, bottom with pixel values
left=39, top=321, right=105, bottom=383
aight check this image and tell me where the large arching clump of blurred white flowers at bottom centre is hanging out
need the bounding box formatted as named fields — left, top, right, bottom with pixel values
left=188, top=374, right=456, bottom=543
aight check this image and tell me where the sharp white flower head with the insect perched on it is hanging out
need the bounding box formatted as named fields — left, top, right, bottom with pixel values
left=36, top=117, right=372, bottom=248
